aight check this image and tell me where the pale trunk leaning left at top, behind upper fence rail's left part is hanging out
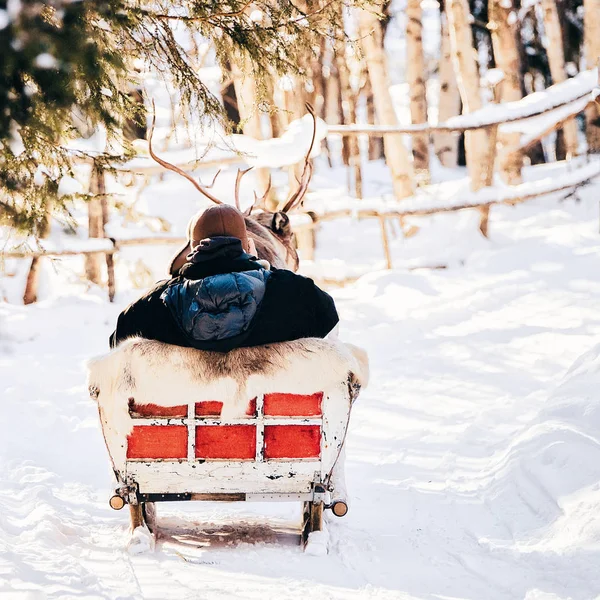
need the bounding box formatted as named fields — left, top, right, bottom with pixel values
left=358, top=1, right=413, bottom=200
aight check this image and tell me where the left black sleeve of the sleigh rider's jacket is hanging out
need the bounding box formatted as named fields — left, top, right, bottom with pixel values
left=109, top=281, right=182, bottom=348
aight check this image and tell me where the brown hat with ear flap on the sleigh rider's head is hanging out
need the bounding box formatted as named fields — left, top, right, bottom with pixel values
left=169, top=204, right=250, bottom=275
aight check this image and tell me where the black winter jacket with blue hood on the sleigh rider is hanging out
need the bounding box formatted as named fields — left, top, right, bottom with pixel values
left=110, top=237, right=339, bottom=352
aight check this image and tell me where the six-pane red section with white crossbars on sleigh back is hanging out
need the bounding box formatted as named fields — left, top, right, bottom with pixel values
left=127, top=392, right=323, bottom=462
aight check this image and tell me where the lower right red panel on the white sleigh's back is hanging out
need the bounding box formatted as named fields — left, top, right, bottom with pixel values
left=265, top=425, right=321, bottom=460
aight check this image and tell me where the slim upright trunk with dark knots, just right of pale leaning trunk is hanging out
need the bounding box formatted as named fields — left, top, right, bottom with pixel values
left=406, top=0, right=431, bottom=185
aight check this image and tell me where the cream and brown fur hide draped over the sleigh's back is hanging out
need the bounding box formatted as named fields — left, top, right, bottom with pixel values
left=87, top=338, right=369, bottom=466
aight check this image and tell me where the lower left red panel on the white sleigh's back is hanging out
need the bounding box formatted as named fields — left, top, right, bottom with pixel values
left=127, top=425, right=187, bottom=458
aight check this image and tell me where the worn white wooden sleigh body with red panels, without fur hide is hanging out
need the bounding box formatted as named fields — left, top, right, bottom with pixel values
left=89, top=340, right=365, bottom=544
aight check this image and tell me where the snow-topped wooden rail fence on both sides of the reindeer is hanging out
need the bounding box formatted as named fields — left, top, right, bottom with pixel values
left=2, top=70, right=600, bottom=303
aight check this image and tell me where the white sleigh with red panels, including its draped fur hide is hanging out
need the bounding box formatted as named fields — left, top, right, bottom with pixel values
left=88, top=339, right=368, bottom=542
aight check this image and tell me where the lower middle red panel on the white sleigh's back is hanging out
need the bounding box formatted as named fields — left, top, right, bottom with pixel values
left=196, top=425, right=256, bottom=460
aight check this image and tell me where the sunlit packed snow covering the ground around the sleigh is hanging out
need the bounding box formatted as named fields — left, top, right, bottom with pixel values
left=0, top=195, right=600, bottom=600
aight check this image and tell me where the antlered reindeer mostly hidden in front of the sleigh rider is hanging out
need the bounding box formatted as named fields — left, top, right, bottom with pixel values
left=148, top=104, right=317, bottom=275
